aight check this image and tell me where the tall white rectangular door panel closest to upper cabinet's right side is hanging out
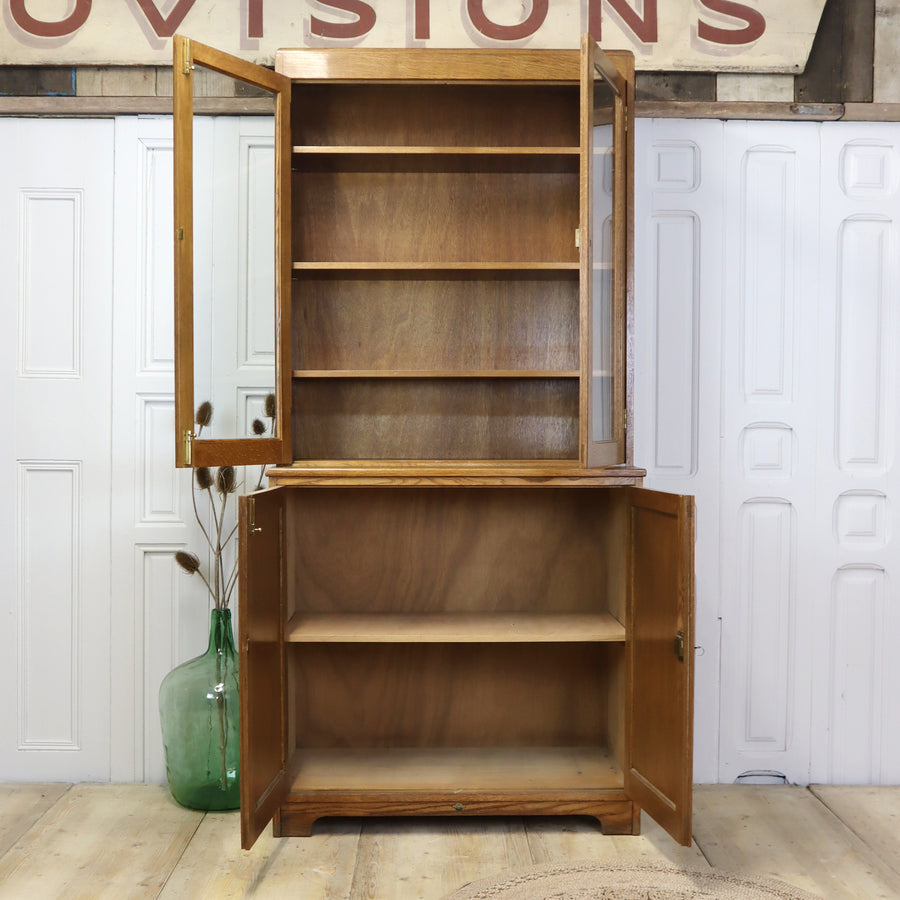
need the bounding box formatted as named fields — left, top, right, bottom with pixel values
left=650, top=214, right=700, bottom=476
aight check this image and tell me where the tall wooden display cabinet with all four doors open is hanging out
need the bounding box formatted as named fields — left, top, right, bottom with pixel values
left=175, top=38, right=693, bottom=847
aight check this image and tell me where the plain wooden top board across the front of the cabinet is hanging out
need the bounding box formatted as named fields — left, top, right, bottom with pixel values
left=275, top=48, right=581, bottom=82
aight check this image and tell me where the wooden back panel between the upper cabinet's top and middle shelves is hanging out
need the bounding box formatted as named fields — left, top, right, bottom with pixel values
left=292, top=172, right=579, bottom=263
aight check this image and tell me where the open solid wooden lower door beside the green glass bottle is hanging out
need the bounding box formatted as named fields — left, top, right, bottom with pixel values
left=238, top=488, right=288, bottom=850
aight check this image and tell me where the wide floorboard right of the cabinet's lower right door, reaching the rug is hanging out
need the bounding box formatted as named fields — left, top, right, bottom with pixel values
left=694, top=785, right=900, bottom=900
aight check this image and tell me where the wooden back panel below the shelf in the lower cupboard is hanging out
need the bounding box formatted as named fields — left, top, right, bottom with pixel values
left=288, top=644, right=608, bottom=748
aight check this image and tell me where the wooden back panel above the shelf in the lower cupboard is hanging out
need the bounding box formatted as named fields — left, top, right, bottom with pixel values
left=286, top=487, right=627, bottom=621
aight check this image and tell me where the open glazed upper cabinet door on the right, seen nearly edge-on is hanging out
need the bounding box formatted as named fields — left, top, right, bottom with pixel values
left=579, top=36, right=634, bottom=468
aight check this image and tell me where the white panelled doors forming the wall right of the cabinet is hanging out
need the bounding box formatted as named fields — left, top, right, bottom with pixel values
left=635, top=120, right=900, bottom=783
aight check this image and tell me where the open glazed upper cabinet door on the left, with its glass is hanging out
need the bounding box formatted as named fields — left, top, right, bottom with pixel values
left=173, top=35, right=291, bottom=466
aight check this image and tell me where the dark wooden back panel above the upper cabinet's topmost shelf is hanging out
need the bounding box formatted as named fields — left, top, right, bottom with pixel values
left=291, top=84, right=579, bottom=147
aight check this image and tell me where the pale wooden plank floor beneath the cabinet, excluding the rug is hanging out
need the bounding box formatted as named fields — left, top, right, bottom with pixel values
left=0, top=784, right=900, bottom=900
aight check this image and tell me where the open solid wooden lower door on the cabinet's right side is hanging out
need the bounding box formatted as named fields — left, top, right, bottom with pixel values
left=625, top=488, right=694, bottom=846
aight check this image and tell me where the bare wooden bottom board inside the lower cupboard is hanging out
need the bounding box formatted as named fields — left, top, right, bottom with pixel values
left=291, top=747, right=623, bottom=793
